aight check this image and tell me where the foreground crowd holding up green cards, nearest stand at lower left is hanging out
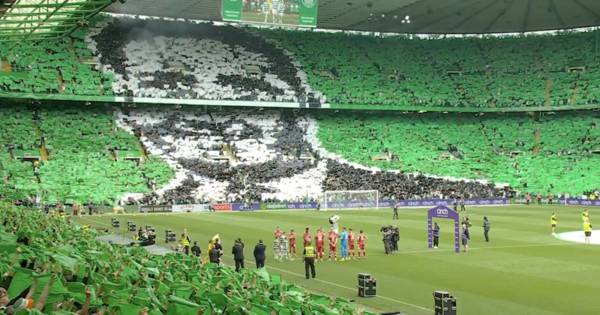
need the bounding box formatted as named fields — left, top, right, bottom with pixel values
left=0, top=203, right=372, bottom=315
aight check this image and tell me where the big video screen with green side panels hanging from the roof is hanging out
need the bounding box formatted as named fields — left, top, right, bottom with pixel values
left=221, top=0, right=319, bottom=27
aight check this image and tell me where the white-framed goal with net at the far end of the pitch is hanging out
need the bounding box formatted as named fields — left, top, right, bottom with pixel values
left=321, top=190, right=379, bottom=210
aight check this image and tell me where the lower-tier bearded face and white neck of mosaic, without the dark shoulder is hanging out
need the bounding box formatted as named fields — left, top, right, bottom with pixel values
left=118, top=109, right=324, bottom=204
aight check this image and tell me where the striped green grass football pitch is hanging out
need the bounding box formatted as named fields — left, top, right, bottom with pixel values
left=78, top=205, right=600, bottom=315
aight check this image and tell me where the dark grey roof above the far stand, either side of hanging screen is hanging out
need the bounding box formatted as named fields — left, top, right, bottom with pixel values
left=108, top=0, right=600, bottom=34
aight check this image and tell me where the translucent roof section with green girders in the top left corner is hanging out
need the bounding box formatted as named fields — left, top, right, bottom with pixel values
left=0, top=0, right=113, bottom=42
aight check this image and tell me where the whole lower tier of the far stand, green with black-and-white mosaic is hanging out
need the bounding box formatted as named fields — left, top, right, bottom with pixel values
left=0, top=106, right=600, bottom=205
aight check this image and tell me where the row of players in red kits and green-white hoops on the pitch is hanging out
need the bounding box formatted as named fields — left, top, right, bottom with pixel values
left=273, top=227, right=367, bottom=261
